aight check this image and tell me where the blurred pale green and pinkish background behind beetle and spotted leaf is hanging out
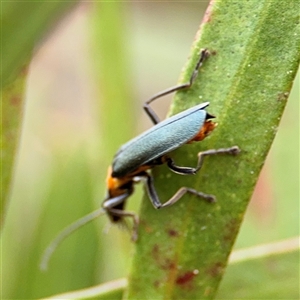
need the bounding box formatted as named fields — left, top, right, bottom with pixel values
left=2, top=2, right=299, bottom=299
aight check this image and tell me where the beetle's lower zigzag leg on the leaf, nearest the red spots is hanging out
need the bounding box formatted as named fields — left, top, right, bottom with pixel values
left=144, top=174, right=216, bottom=209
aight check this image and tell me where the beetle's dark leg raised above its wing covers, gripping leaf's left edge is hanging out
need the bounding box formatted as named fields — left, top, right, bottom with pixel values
left=144, top=49, right=209, bottom=124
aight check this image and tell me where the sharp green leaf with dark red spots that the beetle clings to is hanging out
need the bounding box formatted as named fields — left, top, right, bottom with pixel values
left=127, top=0, right=300, bottom=299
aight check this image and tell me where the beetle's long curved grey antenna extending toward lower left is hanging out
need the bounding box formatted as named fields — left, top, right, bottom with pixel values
left=40, top=207, right=106, bottom=271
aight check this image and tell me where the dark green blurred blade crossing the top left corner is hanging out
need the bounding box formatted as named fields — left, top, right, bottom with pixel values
left=1, top=1, right=77, bottom=88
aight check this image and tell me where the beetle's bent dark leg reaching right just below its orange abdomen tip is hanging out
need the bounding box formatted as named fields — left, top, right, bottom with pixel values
left=167, top=146, right=240, bottom=175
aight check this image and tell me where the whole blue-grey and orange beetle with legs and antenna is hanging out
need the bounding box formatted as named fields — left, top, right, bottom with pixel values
left=41, top=49, right=240, bottom=269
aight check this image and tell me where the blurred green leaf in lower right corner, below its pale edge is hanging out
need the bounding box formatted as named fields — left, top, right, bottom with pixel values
left=216, top=250, right=300, bottom=300
